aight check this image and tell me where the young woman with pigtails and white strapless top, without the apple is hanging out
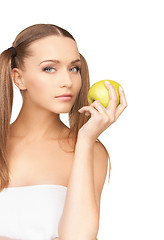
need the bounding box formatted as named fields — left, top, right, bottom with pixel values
left=0, top=24, right=127, bottom=240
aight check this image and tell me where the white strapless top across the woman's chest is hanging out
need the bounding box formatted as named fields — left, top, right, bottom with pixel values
left=0, top=184, right=67, bottom=240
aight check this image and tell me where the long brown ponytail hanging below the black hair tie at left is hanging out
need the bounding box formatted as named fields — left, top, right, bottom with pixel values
left=0, top=49, right=13, bottom=191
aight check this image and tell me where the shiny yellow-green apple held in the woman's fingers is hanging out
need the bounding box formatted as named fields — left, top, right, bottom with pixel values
left=88, top=79, right=122, bottom=108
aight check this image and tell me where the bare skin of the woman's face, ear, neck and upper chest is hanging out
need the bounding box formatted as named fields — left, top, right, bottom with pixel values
left=8, top=36, right=81, bottom=187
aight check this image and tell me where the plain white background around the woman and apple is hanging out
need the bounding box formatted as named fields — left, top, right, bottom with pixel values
left=0, top=0, right=164, bottom=240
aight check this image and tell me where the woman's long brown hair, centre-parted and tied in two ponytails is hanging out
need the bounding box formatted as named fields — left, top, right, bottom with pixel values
left=0, top=24, right=111, bottom=191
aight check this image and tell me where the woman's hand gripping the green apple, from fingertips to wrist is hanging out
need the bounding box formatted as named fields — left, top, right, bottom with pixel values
left=78, top=82, right=127, bottom=142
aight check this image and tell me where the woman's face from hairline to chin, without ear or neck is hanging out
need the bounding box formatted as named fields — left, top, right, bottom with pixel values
left=16, top=36, right=81, bottom=114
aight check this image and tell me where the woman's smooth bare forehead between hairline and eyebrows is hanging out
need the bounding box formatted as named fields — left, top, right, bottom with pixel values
left=29, top=36, right=80, bottom=61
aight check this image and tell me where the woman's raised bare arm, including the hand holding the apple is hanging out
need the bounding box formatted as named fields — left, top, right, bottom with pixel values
left=58, top=83, right=127, bottom=240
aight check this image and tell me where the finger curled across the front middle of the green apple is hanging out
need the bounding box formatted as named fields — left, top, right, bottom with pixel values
left=105, top=81, right=118, bottom=112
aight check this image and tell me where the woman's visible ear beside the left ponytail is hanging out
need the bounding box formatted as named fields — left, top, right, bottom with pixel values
left=11, top=68, right=26, bottom=90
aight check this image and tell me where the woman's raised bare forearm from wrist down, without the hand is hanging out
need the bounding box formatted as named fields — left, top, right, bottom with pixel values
left=58, top=134, right=99, bottom=240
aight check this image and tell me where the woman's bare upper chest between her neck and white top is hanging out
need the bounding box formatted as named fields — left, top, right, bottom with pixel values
left=8, top=124, right=74, bottom=187
